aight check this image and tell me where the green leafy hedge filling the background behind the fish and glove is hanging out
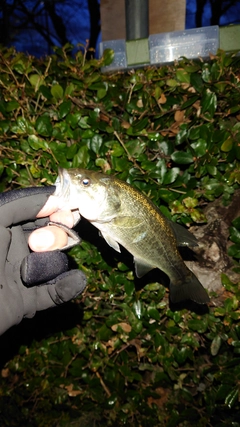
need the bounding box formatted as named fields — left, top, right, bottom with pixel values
left=0, top=45, right=240, bottom=427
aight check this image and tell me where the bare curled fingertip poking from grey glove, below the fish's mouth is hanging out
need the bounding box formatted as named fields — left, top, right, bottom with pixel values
left=28, top=226, right=68, bottom=252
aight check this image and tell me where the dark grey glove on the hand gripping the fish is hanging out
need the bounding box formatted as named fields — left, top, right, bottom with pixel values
left=0, top=186, right=86, bottom=334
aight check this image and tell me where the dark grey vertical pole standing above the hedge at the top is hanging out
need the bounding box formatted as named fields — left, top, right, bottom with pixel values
left=125, top=0, right=149, bottom=40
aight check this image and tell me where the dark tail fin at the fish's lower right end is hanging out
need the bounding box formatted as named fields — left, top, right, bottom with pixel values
left=169, top=271, right=210, bottom=304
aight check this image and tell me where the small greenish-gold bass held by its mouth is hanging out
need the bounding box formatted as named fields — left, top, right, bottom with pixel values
left=54, top=169, right=209, bottom=304
